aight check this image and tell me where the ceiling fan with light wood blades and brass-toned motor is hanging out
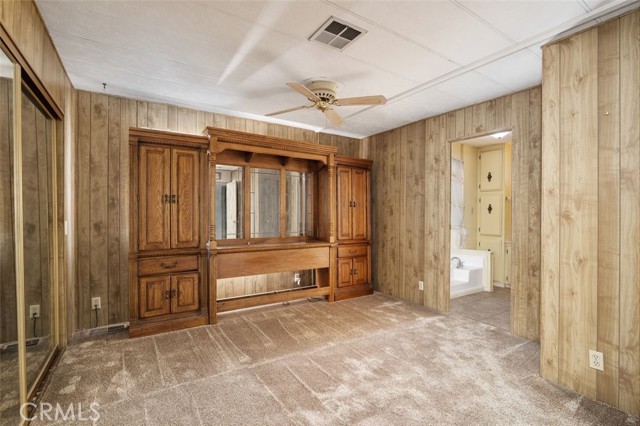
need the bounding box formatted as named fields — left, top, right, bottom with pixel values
left=267, top=80, right=387, bottom=126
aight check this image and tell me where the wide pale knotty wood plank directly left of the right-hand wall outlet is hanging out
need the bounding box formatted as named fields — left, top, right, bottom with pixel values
left=559, top=31, right=598, bottom=397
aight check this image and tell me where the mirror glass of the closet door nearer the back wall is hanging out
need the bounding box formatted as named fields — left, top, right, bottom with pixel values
left=21, top=90, right=56, bottom=387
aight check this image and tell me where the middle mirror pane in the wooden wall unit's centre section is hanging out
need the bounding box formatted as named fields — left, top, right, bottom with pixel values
left=251, top=167, right=280, bottom=238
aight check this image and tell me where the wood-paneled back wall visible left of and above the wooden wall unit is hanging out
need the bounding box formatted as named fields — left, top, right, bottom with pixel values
left=76, top=91, right=360, bottom=328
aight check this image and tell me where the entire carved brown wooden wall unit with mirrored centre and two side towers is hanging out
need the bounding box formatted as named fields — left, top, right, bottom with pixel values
left=129, top=127, right=372, bottom=336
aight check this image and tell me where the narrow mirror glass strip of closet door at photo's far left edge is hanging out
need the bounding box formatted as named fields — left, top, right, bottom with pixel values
left=0, top=50, right=20, bottom=424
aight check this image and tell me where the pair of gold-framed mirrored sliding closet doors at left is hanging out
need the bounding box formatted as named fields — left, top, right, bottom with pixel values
left=0, top=45, right=61, bottom=426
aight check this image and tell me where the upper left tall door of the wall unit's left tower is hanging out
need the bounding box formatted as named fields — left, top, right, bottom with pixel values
left=138, top=146, right=171, bottom=251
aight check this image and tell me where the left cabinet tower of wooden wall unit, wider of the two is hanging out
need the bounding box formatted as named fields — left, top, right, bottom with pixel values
left=130, top=129, right=210, bottom=336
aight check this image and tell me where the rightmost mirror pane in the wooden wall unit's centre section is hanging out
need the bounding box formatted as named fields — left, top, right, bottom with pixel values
left=285, top=171, right=313, bottom=237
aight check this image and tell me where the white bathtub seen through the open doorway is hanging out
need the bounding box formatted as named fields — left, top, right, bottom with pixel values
left=450, top=249, right=493, bottom=299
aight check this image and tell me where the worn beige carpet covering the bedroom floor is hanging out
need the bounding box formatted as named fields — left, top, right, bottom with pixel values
left=34, top=294, right=638, bottom=426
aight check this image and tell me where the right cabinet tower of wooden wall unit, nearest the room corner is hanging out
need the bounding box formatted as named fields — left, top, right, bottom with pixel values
left=334, top=156, right=373, bottom=300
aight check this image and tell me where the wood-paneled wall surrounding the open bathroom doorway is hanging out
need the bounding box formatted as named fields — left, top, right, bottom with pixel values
left=362, top=87, right=541, bottom=340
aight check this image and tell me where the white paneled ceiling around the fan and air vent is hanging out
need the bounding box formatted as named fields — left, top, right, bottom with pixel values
left=36, top=0, right=640, bottom=137
